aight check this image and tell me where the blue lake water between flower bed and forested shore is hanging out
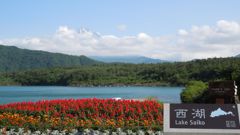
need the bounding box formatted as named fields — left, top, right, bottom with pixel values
left=0, top=86, right=183, bottom=104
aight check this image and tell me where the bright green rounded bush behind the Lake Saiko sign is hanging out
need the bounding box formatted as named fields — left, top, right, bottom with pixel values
left=181, top=81, right=208, bottom=103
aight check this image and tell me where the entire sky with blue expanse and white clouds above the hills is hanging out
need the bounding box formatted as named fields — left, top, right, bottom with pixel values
left=0, top=0, right=240, bottom=61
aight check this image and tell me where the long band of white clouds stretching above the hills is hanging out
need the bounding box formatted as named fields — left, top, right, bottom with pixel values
left=0, top=20, right=240, bottom=61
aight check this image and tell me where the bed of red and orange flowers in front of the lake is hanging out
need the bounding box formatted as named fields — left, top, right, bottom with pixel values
left=0, top=99, right=163, bottom=131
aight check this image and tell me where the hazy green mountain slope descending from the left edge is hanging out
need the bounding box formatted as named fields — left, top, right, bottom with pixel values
left=0, top=45, right=98, bottom=72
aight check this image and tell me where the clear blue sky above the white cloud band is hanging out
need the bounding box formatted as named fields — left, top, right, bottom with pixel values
left=0, top=0, right=240, bottom=60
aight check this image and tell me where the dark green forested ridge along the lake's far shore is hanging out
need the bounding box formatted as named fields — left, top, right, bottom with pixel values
left=0, top=58, right=240, bottom=86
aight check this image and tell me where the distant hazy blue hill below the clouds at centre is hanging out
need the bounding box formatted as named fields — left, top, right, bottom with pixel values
left=89, top=56, right=166, bottom=64
